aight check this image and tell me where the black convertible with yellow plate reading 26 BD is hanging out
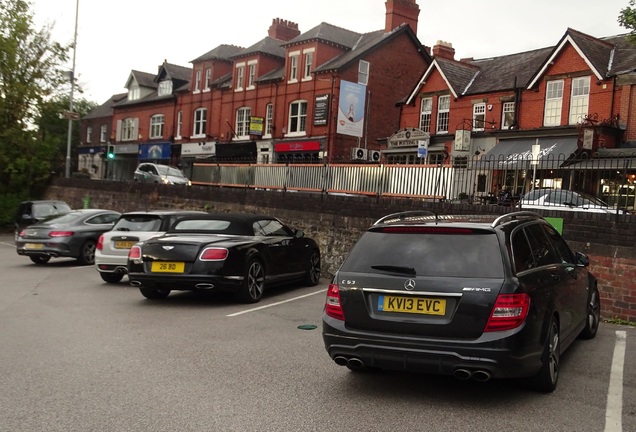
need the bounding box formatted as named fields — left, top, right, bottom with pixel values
left=128, top=214, right=320, bottom=303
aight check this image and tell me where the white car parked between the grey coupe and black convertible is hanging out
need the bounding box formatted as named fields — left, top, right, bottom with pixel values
left=95, top=210, right=207, bottom=283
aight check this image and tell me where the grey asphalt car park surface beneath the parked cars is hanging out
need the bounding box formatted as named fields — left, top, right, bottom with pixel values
left=0, top=235, right=636, bottom=432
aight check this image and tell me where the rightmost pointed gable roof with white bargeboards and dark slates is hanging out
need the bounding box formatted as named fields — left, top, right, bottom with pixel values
left=528, top=28, right=614, bottom=89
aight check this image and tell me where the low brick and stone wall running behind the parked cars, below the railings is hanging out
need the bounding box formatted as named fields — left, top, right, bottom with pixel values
left=46, top=178, right=636, bottom=322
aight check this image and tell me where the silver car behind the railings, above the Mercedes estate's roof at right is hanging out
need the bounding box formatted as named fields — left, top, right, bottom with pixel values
left=518, top=188, right=623, bottom=214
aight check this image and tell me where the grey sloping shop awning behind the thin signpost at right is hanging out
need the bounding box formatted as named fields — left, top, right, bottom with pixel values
left=475, top=137, right=578, bottom=170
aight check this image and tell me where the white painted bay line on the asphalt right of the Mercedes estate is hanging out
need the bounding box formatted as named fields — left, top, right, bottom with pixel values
left=605, top=331, right=627, bottom=432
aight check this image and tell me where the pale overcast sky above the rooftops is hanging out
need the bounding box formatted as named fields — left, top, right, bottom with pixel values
left=29, top=0, right=629, bottom=104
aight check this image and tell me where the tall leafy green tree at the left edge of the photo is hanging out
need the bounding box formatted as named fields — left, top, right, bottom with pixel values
left=0, top=0, right=69, bottom=193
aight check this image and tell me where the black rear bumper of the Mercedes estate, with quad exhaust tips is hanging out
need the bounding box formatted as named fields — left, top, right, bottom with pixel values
left=322, top=313, right=543, bottom=379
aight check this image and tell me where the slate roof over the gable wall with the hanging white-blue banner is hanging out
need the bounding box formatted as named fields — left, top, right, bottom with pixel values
left=315, top=24, right=431, bottom=73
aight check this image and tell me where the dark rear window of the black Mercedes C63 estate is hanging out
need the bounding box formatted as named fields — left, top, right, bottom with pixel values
left=341, top=231, right=503, bottom=278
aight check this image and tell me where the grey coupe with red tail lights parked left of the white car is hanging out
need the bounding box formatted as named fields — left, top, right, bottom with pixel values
left=16, top=209, right=121, bottom=265
